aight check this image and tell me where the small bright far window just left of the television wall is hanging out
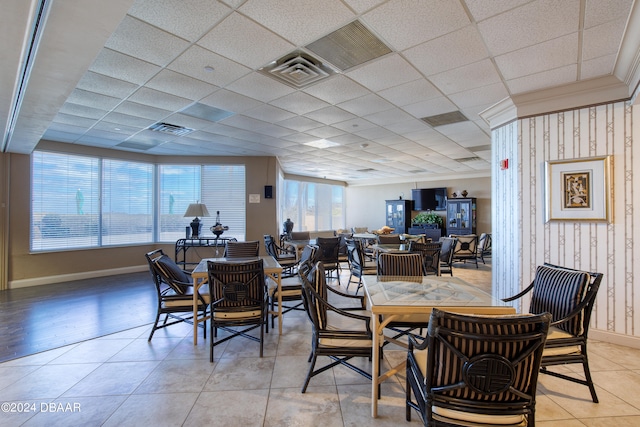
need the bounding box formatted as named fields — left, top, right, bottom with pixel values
left=281, top=179, right=345, bottom=231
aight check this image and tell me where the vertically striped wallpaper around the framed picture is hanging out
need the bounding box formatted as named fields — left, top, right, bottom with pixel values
left=492, top=102, right=640, bottom=346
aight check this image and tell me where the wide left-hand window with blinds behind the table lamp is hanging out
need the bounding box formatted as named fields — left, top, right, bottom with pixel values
left=31, top=151, right=246, bottom=252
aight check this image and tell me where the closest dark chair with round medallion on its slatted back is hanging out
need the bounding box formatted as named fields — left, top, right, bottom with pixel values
left=405, top=308, right=551, bottom=427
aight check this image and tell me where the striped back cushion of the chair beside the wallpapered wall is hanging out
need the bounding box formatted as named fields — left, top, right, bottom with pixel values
left=529, top=265, right=590, bottom=335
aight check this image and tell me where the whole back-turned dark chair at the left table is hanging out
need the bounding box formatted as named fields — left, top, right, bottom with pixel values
left=207, top=259, right=268, bottom=362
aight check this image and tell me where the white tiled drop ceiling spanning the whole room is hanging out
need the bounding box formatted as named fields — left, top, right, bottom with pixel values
left=0, top=0, right=640, bottom=184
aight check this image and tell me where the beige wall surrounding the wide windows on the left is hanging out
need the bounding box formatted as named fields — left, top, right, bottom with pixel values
left=7, top=142, right=279, bottom=287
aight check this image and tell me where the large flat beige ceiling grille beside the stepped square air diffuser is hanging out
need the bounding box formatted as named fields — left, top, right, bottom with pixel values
left=305, top=21, right=391, bottom=71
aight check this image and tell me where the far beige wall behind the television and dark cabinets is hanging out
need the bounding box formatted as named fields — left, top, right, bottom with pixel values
left=346, top=177, right=491, bottom=234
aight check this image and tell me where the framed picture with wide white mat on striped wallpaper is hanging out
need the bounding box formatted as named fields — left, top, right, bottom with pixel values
left=545, top=156, right=611, bottom=222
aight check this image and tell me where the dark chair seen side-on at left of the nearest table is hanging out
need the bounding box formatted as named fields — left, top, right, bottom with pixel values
left=300, top=261, right=373, bottom=393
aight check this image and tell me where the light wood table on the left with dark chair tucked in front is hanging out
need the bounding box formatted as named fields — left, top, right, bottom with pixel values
left=191, top=255, right=283, bottom=345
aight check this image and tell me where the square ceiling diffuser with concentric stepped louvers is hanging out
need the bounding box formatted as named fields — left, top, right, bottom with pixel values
left=260, top=51, right=333, bottom=89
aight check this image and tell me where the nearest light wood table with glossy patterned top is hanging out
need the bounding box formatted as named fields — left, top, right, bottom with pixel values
left=362, top=275, right=515, bottom=418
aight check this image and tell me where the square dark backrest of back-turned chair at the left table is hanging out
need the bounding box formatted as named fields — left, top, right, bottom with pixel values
left=207, top=259, right=266, bottom=311
